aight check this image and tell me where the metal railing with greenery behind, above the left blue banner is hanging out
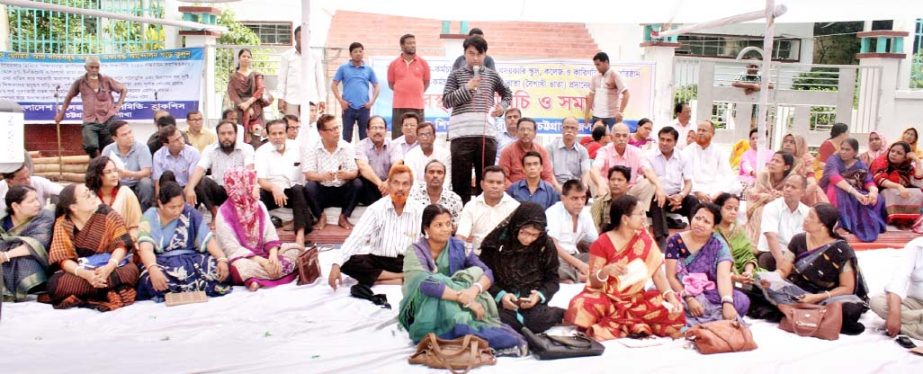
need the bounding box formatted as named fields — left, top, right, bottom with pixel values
left=7, top=0, right=165, bottom=54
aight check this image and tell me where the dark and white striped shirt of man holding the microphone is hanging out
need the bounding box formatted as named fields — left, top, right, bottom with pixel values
left=442, top=66, right=513, bottom=140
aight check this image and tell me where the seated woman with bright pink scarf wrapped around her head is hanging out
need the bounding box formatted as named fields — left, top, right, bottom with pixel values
left=215, top=168, right=300, bottom=291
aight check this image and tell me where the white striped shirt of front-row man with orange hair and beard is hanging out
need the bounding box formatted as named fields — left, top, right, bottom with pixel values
left=334, top=196, right=423, bottom=265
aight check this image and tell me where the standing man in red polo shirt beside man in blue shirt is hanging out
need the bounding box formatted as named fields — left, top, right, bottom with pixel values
left=388, top=34, right=429, bottom=139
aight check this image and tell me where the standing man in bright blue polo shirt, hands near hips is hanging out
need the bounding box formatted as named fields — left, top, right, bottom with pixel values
left=330, top=42, right=380, bottom=142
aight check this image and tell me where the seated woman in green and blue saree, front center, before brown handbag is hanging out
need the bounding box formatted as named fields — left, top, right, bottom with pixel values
left=398, top=204, right=527, bottom=355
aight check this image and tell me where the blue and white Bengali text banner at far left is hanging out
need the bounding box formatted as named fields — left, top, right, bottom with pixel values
left=0, top=48, right=205, bottom=123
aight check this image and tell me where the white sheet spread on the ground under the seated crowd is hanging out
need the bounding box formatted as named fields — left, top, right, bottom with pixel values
left=0, top=250, right=923, bottom=374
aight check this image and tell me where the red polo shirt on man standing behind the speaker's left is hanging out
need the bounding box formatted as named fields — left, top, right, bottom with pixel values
left=388, top=56, right=429, bottom=109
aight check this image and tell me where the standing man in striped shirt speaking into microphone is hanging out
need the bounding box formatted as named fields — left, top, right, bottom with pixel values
left=442, top=35, right=513, bottom=203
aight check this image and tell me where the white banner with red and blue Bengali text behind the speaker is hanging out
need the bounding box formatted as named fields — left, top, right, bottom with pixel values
left=372, top=57, right=654, bottom=134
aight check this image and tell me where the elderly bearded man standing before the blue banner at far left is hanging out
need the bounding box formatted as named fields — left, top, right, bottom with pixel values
left=54, top=56, right=128, bottom=158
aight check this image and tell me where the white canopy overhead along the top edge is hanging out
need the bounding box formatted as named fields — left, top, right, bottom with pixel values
left=324, top=0, right=923, bottom=24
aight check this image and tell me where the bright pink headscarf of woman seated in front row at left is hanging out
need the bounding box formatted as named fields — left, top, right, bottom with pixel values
left=224, top=168, right=263, bottom=248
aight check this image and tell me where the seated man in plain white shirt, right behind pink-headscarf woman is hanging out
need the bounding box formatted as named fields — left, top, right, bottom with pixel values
left=255, top=119, right=311, bottom=246
